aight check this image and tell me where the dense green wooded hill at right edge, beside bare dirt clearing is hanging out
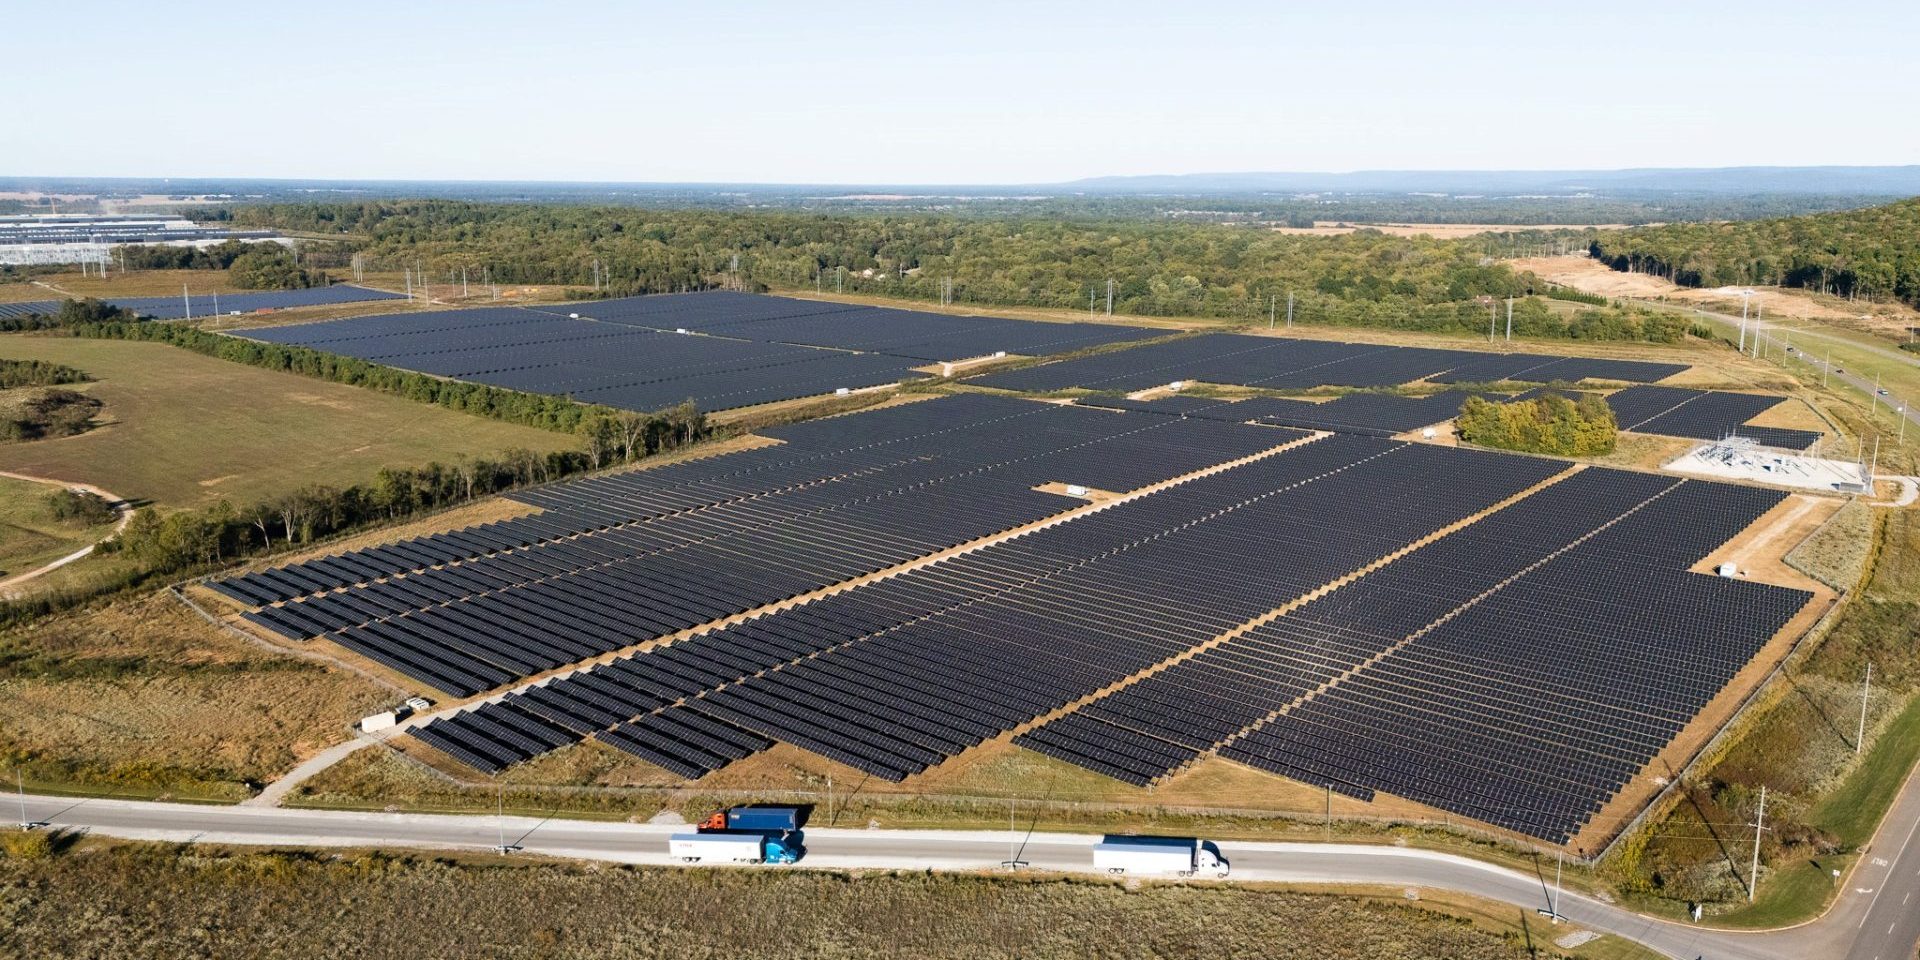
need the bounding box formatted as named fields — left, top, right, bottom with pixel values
left=1592, top=198, right=1920, bottom=305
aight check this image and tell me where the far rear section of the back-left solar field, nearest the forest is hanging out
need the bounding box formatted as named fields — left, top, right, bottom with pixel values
left=538, top=290, right=1162, bottom=361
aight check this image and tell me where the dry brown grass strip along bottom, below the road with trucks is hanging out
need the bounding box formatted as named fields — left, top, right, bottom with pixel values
left=0, top=835, right=1605, bottom=960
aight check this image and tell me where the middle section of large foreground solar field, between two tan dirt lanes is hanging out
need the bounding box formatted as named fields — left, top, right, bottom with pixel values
left=424, top=435, right=1559, bottom=780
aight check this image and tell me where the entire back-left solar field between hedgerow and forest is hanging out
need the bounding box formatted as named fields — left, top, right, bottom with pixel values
left=238, top=292, right=1154, bottom=411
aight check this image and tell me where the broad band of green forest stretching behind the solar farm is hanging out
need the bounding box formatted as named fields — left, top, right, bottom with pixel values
left=214, top=202, right=1682, bottom=340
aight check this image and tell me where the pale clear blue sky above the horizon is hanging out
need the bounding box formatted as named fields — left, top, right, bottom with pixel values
left=18, top=0, right=1920, bottom=182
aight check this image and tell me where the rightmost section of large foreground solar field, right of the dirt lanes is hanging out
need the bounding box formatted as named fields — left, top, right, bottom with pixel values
left=1016, top=468, right=1809, bottom=843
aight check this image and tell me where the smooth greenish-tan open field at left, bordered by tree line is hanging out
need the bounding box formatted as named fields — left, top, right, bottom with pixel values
left=0, top=334, right=578, bottom=509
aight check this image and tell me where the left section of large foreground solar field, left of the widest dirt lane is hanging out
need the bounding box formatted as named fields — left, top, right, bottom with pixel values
left=213, top=397, right=1302, bottom=695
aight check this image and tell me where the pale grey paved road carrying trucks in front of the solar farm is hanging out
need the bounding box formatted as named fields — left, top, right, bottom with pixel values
left=23, top=783, right=1920, bottom=960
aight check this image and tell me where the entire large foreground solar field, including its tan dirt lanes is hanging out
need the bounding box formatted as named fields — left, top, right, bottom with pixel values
left=211, top=394, right=1814, bottom=845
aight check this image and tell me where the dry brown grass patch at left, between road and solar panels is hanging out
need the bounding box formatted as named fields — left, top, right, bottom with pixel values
left=0, top=591, right=392, bottom=799
